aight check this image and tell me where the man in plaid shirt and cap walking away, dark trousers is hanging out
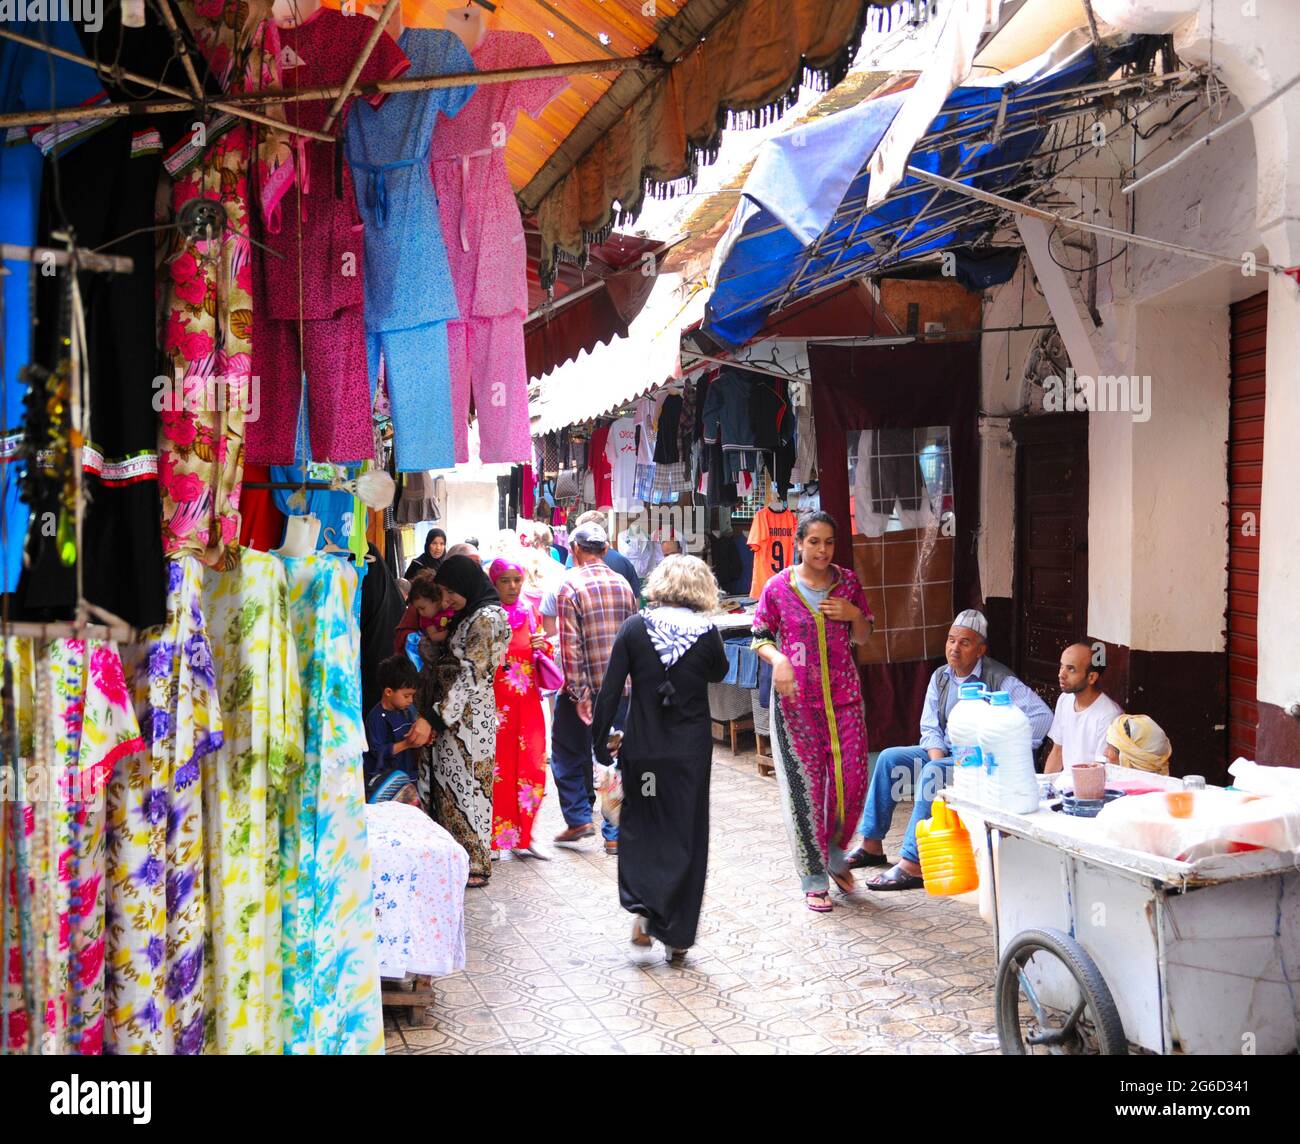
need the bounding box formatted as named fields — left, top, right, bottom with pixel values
left=551, top=524, right=637, bottom=854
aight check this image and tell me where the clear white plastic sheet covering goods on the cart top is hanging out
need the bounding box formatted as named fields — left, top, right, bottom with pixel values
left=1096, top=788, right=1300, bottom=862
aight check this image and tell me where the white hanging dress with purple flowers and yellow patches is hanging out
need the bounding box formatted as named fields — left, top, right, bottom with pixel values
left=105, top=556, right=222, bottom=1056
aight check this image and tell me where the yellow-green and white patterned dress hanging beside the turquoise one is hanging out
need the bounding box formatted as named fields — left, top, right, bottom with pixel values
left=200, top=549, right=303, bottom=1054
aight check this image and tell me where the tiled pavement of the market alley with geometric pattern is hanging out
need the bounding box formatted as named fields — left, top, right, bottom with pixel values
left=385, top=748, right=996, bottom=1056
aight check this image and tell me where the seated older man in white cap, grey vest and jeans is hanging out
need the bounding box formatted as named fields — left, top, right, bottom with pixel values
left=849, top=608, right=1052, bottom=891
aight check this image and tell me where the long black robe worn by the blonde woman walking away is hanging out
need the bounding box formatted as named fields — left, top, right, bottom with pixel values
left=592, top=615, right=727, bottom=949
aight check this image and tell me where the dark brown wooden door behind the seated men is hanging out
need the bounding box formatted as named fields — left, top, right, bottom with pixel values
left=1011, top=413, right=1088, bottom=707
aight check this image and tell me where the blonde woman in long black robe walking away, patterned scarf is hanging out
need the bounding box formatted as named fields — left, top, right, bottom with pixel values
left=592, top=556, right=727, bottom=958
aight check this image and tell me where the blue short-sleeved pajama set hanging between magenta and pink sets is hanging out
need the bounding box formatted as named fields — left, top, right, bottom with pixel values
left=347, top=27, right=475, bottom=472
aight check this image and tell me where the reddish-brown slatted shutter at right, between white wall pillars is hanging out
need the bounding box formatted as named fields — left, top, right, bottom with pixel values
left=1225, top=293, right=1269, bottom=763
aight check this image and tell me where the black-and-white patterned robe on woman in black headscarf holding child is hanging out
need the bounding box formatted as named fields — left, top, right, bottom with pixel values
left=420, top=605, right=510, bottom=878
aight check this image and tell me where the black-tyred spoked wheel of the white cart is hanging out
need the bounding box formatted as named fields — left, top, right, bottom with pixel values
left=996, top=930, right=1128, bottom=1057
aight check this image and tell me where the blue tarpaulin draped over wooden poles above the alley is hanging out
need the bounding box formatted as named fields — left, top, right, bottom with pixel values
left=705, top=38, right=1141, bottom=346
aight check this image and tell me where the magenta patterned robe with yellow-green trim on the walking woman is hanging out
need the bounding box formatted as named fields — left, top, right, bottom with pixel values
left=754, top=567, right=870, bottom=891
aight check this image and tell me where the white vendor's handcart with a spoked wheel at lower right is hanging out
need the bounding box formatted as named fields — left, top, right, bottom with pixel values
left=944, top=790, right=1300, bottom=1054
